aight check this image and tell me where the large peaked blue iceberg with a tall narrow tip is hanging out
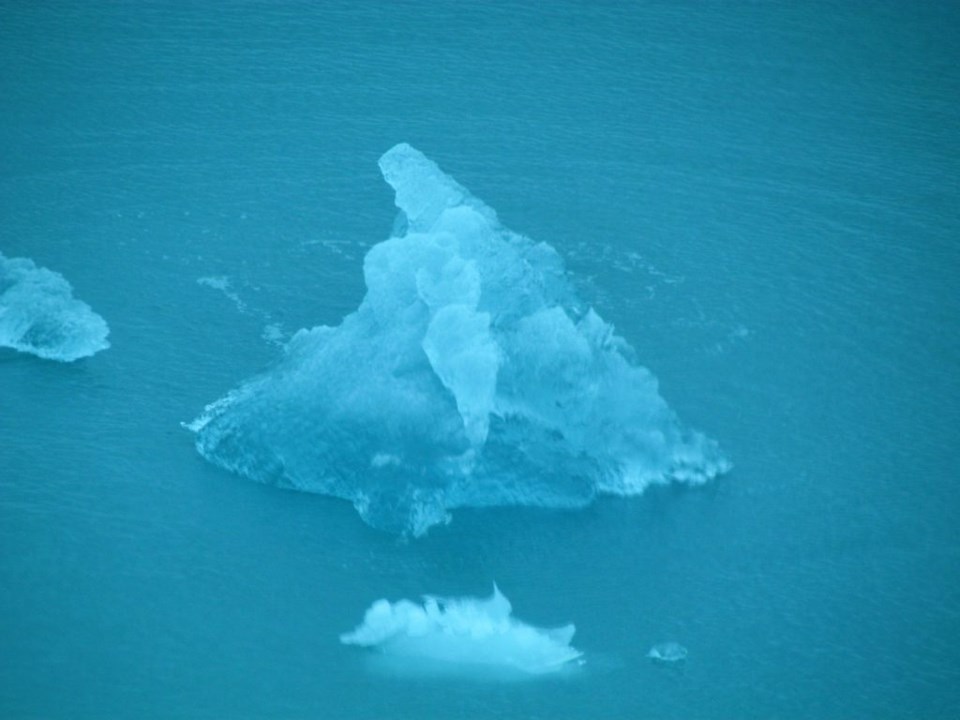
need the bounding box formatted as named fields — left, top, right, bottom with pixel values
left=188, top=144, right=728, bottom=535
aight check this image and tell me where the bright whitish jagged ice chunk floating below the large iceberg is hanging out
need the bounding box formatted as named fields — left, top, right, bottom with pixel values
left=340, top=585, right=583, bottom=675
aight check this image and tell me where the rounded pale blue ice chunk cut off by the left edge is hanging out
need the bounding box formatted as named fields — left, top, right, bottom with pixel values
left=0, top=253, right=110, bottom=362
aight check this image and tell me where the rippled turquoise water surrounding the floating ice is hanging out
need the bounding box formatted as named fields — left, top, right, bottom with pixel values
left=0, top=2, right=960, bottom=718
